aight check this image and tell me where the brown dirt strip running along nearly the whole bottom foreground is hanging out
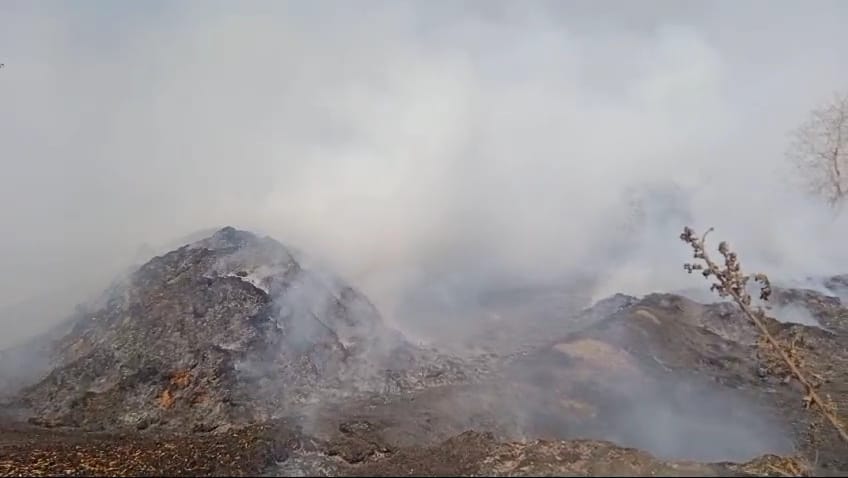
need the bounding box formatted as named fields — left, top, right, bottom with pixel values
left=0, top=421, right=808, bottom=476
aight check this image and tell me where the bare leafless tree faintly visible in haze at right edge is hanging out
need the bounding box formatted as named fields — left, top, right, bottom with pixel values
left=787, top=94, right=848, bottom=208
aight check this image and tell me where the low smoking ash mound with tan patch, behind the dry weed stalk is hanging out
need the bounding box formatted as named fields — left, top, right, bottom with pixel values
left=504, top=289, right=848, bottom=470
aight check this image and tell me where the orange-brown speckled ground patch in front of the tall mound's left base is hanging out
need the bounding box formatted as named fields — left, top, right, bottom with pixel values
left=0, top=424, right=286, bottom=476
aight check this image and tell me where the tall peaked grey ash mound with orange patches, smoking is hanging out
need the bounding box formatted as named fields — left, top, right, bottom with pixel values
left=7, top=227, right=468, bottom=430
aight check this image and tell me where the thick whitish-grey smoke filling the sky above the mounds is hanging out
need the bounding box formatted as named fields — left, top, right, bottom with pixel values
left=0, top=1, right=848, bottom=344
